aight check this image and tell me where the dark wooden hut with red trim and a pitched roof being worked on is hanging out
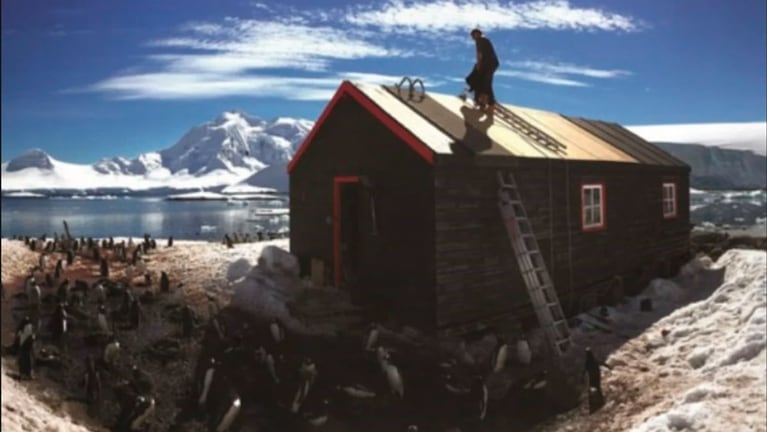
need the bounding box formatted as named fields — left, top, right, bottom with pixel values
left=288, top=81, right=691, bottom=333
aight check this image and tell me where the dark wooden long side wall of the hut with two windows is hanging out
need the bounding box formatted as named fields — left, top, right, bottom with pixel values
left=435, top=156, right=690, bottom=328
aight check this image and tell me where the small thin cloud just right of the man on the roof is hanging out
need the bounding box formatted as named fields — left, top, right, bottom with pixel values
left=497, top=60, right=631, bottom=87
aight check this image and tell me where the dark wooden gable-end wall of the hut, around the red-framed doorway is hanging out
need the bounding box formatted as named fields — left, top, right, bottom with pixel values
left=290, top=99, right=435, bottom=327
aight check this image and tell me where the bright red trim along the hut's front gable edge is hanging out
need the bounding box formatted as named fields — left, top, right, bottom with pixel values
left=288, top=81, right=434, bottom=173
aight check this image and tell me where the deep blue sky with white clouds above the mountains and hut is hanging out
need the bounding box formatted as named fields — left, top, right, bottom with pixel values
left=0, top=0, right=767, bottom=163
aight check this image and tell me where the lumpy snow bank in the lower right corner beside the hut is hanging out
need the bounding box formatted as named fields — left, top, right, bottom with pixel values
left=560, top=249, right=767, bottom=432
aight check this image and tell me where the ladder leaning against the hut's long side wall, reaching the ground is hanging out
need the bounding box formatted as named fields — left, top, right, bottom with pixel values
left=498, top=171, right=572, bottom=357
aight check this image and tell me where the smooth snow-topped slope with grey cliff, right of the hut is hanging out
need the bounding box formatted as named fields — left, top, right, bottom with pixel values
left=629, top=122, right=767, bottom=189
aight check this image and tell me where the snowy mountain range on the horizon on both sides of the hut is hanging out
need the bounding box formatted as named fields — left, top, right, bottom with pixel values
left=2, top=115, right=767, bottom=195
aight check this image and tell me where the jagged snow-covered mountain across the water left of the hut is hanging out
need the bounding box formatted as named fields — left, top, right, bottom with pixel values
left=2, top=111, right=313, bottom=191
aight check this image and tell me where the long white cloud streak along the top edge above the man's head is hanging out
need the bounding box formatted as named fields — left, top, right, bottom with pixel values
left=345, top=0, right=645, bottom=36
